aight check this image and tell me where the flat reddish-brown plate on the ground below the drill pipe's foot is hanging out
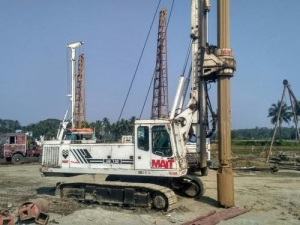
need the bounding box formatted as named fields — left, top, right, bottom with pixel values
left=182, top=206, right=250, bottom=225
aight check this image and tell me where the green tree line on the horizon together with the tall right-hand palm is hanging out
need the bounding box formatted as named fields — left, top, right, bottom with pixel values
left=0, top=101, right=300, bottom=142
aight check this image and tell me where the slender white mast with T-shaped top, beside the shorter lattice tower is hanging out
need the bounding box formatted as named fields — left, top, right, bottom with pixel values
left=67, top=41, right=83, bottom=127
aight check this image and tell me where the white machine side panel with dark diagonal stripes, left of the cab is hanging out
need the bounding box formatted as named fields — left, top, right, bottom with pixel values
left=43, top=144, right=134, bottom=172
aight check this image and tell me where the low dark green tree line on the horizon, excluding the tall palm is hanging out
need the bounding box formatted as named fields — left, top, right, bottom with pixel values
left=0, top=117, right=297, bottom=142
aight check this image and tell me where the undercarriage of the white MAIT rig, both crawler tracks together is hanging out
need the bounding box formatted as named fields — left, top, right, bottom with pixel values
left=55, top=175, right=204, bottom=211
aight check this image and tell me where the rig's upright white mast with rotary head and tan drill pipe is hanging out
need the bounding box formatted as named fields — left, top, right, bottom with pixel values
left=191, top=0, right=236, bottom=207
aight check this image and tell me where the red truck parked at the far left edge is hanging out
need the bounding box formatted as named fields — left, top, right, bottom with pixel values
left=0, top=133, right=42, bottom=164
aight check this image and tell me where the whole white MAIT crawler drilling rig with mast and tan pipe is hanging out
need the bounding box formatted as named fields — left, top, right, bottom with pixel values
left=41, top=0, right=235, bottom=210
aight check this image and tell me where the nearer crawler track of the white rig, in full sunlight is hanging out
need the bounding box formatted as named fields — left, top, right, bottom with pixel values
left=56, top=181, right=177, bottom=211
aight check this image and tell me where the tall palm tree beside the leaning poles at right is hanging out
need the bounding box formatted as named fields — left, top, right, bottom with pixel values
left=268, top=101, right=293, bottom=138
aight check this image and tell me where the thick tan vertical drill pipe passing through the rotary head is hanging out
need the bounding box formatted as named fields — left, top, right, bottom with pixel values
left=217, top=0, right=234, bottom=208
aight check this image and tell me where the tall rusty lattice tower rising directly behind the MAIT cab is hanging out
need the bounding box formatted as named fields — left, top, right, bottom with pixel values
left=151, top=9, right=169, bottom=119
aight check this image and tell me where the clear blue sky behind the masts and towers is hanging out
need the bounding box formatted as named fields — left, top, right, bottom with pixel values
left=0, top=0, right=300, bottom=129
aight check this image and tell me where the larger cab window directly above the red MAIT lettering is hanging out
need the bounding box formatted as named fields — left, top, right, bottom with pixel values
left=152, top=126, right=173, bottom=157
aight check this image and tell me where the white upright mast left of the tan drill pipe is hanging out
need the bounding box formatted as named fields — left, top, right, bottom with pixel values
left=191, top=0, right=210, bottom=175
